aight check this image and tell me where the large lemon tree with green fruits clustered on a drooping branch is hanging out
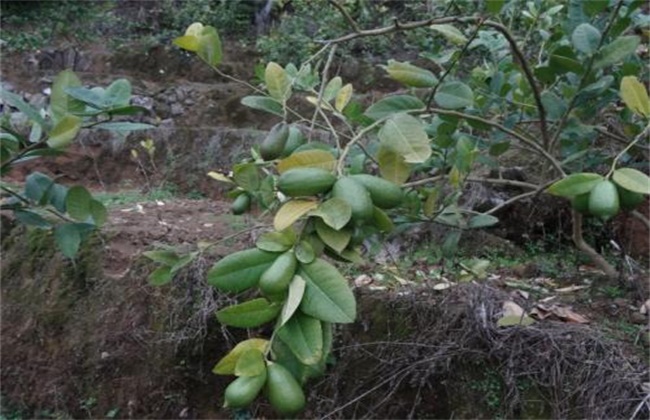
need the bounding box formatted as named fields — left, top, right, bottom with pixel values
left=163, top=0, right=650, bottom=416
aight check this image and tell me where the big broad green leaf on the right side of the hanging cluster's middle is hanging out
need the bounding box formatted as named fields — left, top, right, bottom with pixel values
left=298, top=258, right=357, bottom=323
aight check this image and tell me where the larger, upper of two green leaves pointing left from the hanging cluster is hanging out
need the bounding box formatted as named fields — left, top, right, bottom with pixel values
left=208, top=248, right=278, bottom=293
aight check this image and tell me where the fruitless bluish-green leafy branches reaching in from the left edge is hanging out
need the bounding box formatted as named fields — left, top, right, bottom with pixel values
left=0, top=70, right=152, bottom=258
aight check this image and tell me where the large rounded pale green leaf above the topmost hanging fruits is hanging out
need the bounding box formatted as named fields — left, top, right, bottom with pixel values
left=378, top=114, right=431, bottom=163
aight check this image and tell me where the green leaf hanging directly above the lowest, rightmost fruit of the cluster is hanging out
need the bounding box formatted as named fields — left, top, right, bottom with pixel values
left=276, top=312, right=323, bottom=365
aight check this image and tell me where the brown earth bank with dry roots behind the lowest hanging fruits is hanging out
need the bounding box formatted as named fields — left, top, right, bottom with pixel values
left=1, top=212, right=649, bottom=418
